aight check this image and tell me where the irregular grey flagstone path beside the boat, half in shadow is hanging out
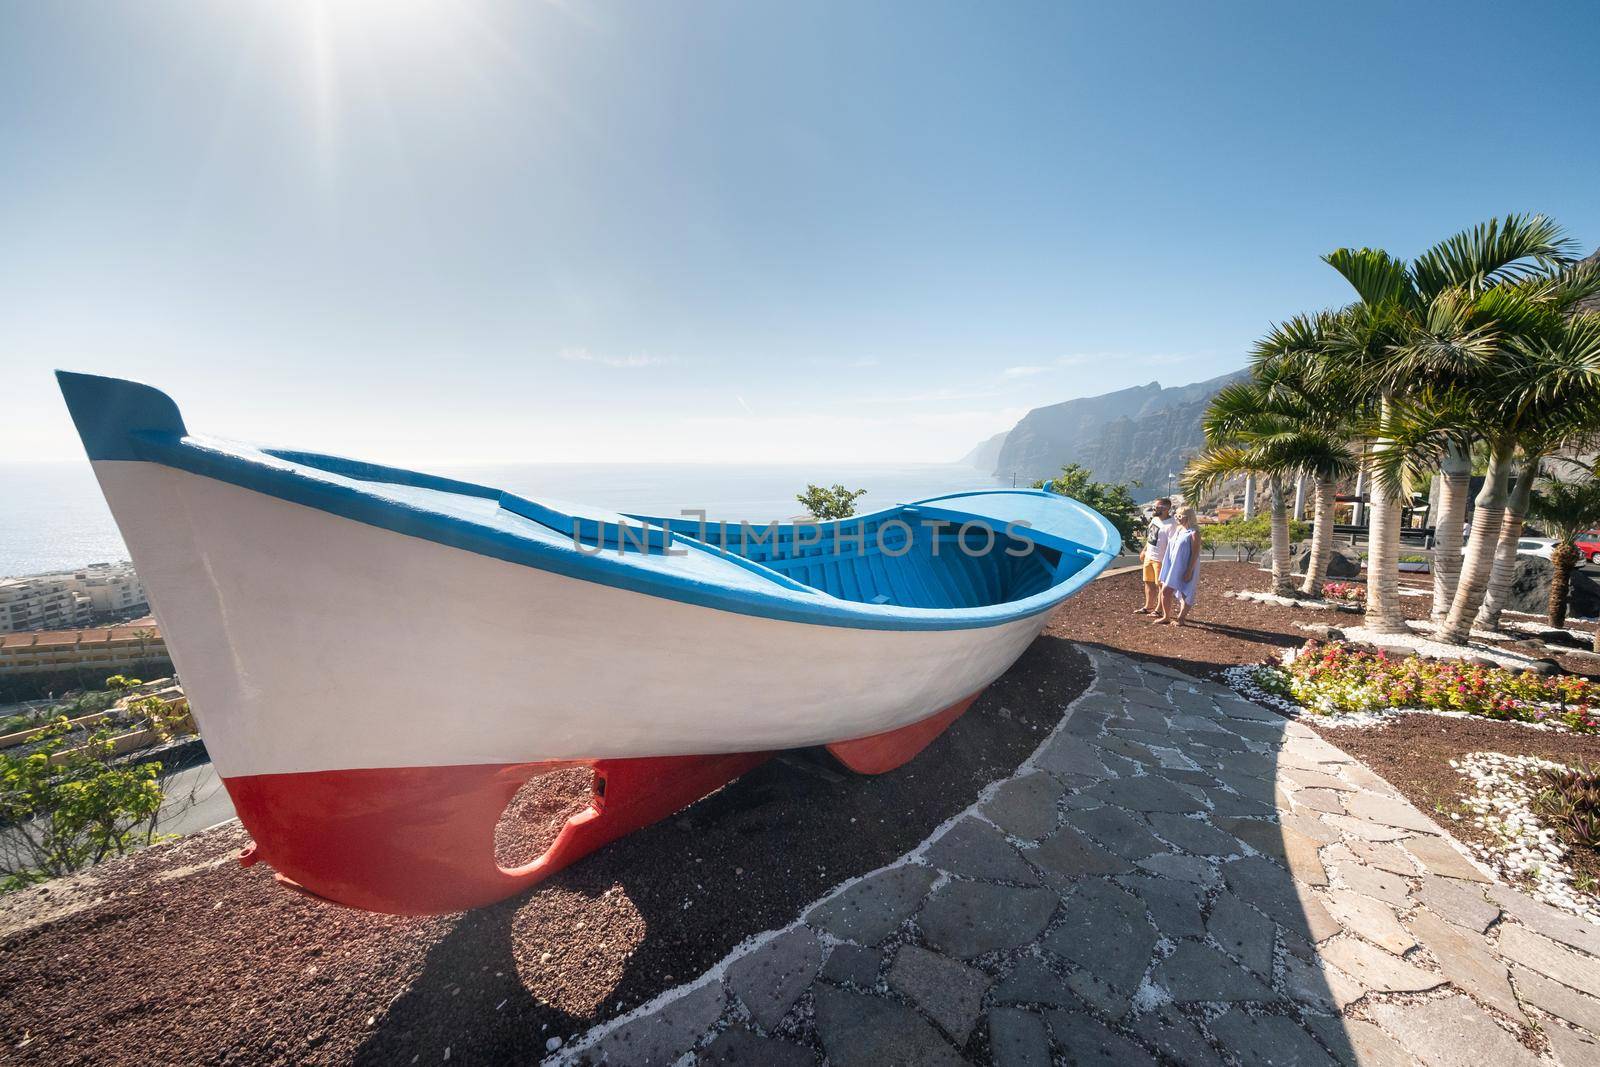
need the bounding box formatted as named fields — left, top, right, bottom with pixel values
left=555, top=653, right=1600, bottom=1067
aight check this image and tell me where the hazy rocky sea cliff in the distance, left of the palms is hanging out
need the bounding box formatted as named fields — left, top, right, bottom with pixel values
left=968, top=371, right=1246, bottom=501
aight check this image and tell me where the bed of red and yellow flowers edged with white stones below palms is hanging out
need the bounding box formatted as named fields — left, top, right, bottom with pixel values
left=1254, top=641, right=1600, bottom=733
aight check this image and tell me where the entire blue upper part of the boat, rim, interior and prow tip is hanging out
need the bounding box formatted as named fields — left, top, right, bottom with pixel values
left=58, top=371, right=1120, bottom=629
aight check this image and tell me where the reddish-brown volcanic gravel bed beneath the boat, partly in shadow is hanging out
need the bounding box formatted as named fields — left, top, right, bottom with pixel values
left=0, top=633, right=1090, bottom=1065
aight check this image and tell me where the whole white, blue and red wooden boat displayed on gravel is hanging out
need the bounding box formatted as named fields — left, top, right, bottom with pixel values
left=59, top=373, right=1120, bottom=913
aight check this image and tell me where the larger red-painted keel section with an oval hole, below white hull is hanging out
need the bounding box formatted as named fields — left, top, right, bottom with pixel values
left=224, top=752, right=771, bottom=915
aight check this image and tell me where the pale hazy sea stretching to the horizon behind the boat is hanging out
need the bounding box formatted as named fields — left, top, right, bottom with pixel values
left=0, top=462, right=1000, bottom=576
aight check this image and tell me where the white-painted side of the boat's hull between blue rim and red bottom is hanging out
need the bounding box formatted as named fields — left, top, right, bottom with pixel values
left=94, top=461, right=1048, bottom=777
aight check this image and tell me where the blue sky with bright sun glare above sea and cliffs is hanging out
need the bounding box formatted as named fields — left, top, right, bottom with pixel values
left=0, top=0, right=1600, bottom=466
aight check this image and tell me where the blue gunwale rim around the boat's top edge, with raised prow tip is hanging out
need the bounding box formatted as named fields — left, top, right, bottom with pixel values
left=56, top=371, right=1122, bottom=630
